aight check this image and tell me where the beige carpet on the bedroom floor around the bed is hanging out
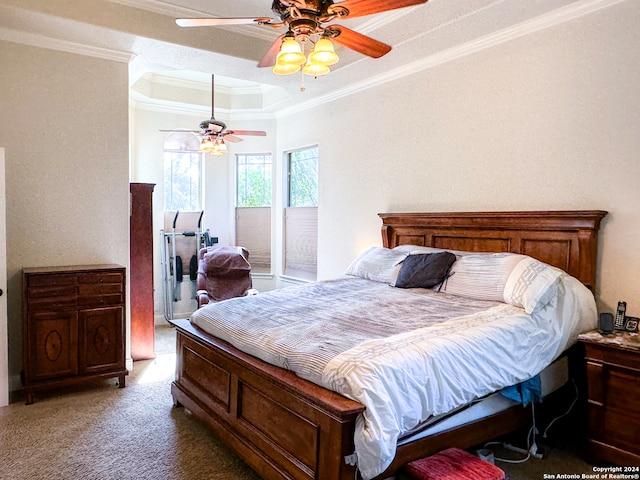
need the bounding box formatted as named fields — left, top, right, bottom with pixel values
left=0, top=328, right=592, bottom=480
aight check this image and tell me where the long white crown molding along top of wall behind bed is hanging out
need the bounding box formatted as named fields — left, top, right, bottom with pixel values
left=276, top=0, right=627, bottom=118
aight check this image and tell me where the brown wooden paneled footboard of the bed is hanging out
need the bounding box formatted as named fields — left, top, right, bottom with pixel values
left=171, top=320, right=364, bottom=480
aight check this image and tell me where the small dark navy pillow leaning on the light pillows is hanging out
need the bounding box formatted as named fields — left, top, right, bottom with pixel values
left=393, top=252, right=456, bottom=288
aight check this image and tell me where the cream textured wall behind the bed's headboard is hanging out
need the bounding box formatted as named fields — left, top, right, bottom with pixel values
left=278, top=2, right=640, bottom=315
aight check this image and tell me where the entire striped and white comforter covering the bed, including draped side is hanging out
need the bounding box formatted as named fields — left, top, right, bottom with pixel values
left=191, top=275, right=596, bottom=479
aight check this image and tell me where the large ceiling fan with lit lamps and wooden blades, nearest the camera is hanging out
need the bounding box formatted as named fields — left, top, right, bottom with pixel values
left=176, top=0, right=427, bottom=75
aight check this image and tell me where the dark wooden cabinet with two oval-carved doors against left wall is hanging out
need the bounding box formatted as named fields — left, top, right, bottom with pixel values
left=22, top=265, right=128, bottom=404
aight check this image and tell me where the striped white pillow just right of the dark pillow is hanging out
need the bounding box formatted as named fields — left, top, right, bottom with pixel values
left=440, top=253, right=526, bottom=302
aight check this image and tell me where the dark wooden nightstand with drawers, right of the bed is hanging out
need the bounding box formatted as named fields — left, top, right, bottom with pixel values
left=578, top=331, right=640, bottom=466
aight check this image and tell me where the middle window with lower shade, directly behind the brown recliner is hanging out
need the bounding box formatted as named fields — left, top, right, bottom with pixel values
left=236, top=154, right=272, bottom=273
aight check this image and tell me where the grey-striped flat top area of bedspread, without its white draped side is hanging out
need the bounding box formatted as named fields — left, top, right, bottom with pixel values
left=191, top=277, right=497, bottom=385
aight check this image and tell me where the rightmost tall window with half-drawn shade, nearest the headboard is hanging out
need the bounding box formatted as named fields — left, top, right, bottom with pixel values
left=284, top=147, right=318, bottom=280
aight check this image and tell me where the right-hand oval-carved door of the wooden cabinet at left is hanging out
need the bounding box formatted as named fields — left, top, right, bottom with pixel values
left=78, top=306, right=124, bottom=374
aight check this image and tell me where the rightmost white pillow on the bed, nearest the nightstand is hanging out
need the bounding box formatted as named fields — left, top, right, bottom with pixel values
left=504, top=257, right=564, bottom=314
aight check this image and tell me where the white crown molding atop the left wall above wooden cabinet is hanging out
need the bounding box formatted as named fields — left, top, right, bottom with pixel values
left=0, top=27, right=135, bottom=63
